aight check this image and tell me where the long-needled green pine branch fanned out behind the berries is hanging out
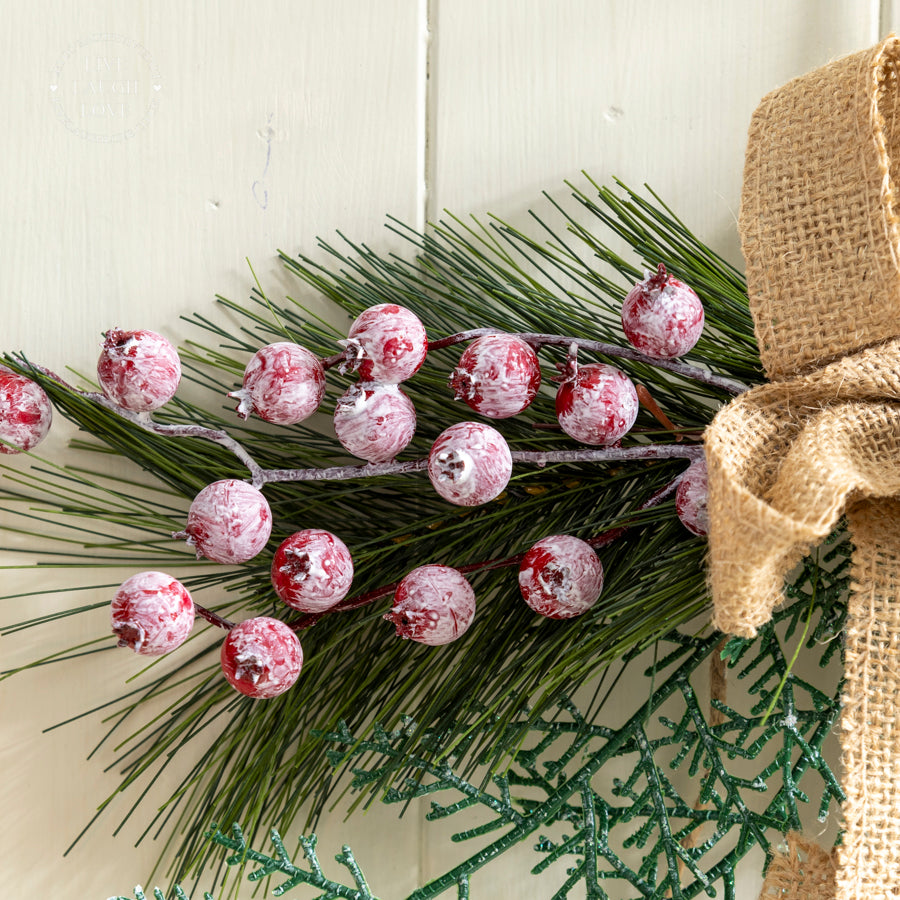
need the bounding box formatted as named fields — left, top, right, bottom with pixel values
left=3, top=178, right=818, bottom=896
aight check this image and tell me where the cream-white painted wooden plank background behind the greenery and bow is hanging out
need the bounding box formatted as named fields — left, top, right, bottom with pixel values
left=0, top=0, right=884, bottom=900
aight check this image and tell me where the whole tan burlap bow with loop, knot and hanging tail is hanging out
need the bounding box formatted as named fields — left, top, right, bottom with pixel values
left=706, top=36, right=900, bottom=900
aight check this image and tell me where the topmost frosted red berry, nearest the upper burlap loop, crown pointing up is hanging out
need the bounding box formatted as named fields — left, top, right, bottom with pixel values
left=622, top=263, right=704, bottom=359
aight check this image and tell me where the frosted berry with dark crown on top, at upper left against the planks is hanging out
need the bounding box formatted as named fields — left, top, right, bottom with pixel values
left=97, top=328, right=181, bottom=412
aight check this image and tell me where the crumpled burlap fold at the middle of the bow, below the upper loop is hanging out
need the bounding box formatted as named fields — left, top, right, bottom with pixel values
left=706, top=339, right=900, bottom=637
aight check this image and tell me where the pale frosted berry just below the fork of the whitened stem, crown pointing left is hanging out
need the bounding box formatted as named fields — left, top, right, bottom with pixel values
left=173, top=479, right=272, bottom=563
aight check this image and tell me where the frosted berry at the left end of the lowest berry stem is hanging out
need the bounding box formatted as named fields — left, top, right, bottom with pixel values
left=109, top=572, right=194, bottom=656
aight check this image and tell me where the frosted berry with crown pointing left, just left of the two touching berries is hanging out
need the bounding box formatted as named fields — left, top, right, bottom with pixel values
left=228, top=341, right=325, bottom=425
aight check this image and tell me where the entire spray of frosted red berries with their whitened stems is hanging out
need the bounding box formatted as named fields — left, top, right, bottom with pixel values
left=0, top=265, right=714, bottom=698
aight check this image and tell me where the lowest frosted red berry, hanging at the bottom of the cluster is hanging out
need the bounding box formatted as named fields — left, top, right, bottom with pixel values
left=222, top=616, right=303, bottom=700
